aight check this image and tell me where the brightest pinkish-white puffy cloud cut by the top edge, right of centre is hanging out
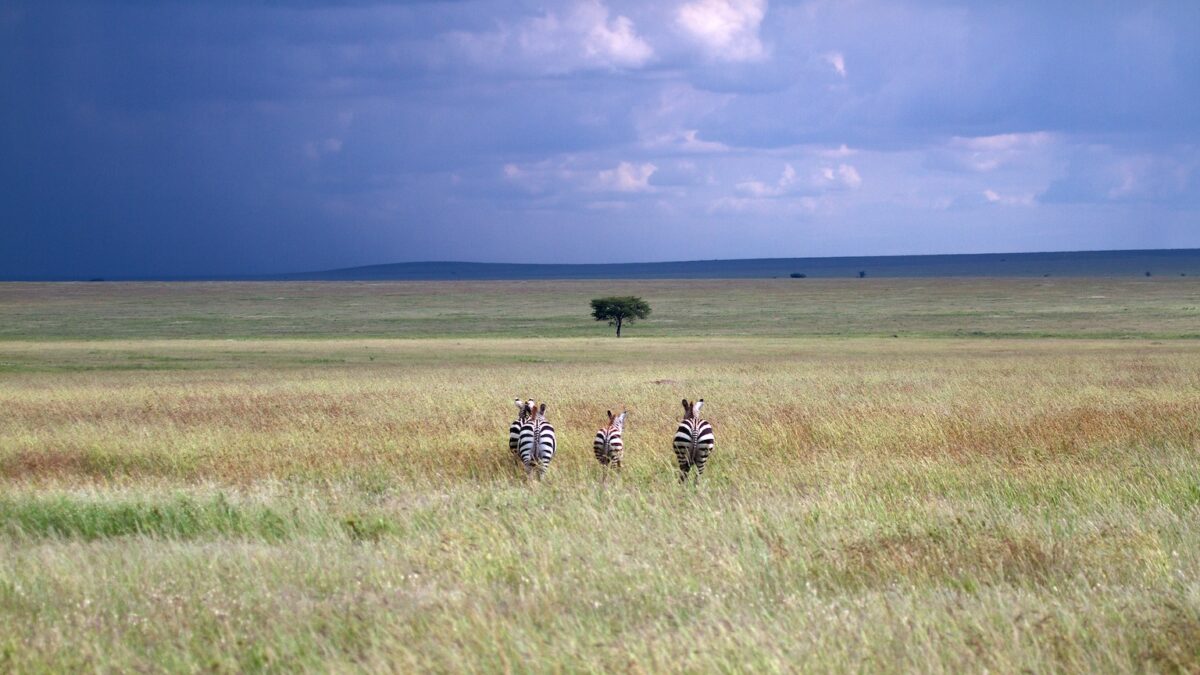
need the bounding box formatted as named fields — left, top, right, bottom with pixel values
left=676, top=0, right=767, bottom=61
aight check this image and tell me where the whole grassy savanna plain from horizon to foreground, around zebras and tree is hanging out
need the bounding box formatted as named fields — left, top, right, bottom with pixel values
left=0, top=277, right=1200, bottom=673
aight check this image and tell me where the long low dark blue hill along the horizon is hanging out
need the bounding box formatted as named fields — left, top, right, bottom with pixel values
left=283, top=249, right=1200, bottom=281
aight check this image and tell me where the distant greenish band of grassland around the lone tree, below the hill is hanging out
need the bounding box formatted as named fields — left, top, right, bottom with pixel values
left=7, top=277, right=1200, bottom=340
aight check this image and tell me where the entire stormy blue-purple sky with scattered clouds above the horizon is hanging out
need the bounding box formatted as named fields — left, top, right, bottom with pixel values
left=0, top=0, right=1200, bottom=277
